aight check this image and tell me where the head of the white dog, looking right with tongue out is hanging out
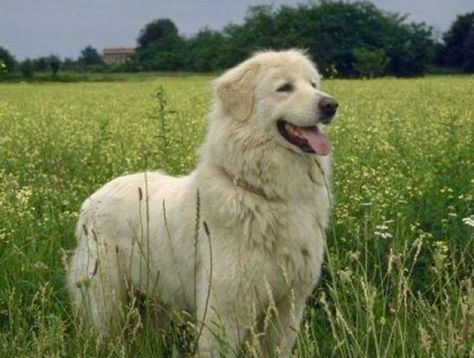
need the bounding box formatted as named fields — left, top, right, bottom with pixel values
left=215, top=50, right=338, bottom=156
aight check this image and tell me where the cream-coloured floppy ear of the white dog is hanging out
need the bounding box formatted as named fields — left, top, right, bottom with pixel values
left=214, top=63, right=258, bottom=121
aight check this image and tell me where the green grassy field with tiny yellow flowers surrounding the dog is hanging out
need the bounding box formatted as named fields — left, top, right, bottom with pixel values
left=0, top=76, right=474, bottom=358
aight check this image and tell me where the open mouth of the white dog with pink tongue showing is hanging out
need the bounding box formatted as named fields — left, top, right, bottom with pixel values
left=277, top=119, right=331, bottom=156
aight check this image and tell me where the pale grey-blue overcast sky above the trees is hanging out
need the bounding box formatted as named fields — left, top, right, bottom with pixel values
left=0, top=0, right=474, bottom=59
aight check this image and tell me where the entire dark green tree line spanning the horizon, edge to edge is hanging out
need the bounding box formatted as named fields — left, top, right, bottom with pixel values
left=0, top=0, right=474, bottom=78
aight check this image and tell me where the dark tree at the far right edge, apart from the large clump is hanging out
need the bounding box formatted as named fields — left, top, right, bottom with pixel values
left=440, top=11, right=474, bottom=70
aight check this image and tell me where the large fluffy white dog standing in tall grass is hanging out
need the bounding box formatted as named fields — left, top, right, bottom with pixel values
left=68, top=50, right=337, bottom=357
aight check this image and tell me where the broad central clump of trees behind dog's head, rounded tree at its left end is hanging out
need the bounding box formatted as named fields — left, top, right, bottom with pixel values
left=130, top=1, right=434, bottom=77
